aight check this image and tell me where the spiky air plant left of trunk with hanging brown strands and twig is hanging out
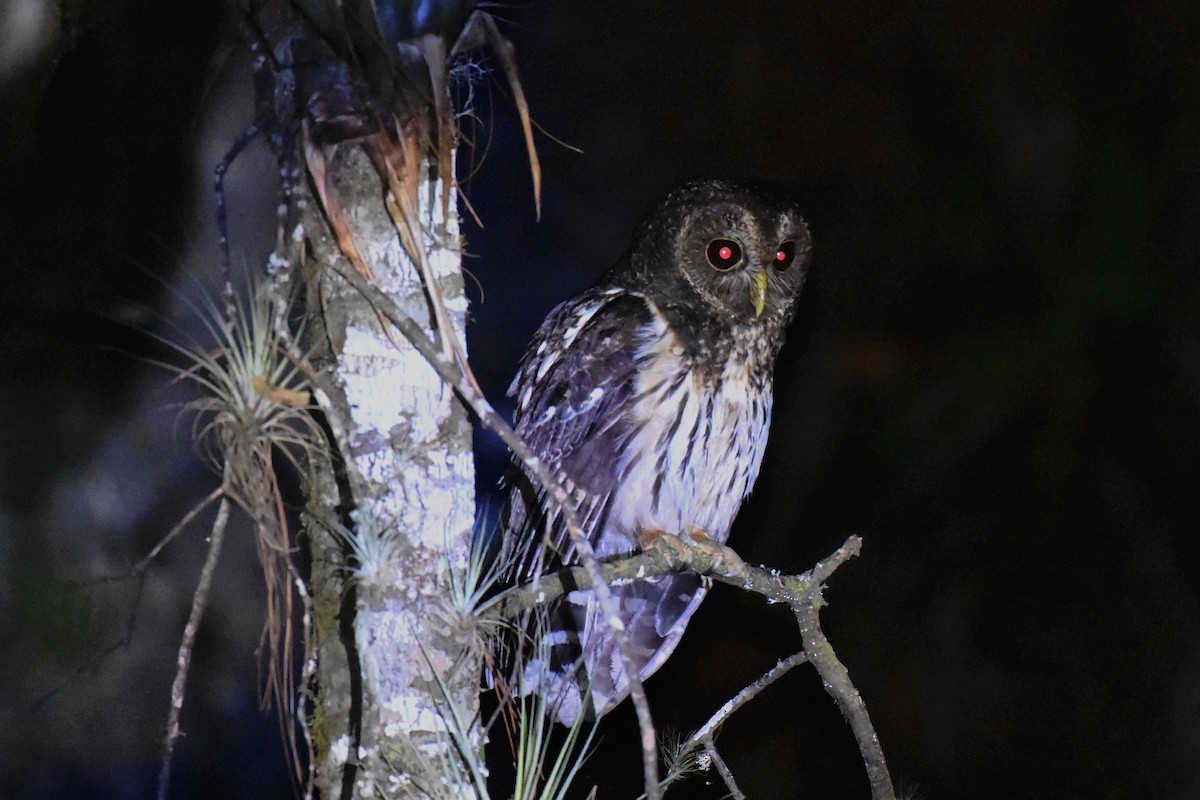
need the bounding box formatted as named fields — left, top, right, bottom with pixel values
left=145, top=273, right=323, bottom=796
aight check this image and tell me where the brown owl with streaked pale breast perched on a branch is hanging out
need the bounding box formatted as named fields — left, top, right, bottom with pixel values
left=500, top=180, right=811, bottom=724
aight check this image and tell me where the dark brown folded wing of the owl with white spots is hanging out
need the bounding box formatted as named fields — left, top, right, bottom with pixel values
left=504, top=288, right=653, bottom=579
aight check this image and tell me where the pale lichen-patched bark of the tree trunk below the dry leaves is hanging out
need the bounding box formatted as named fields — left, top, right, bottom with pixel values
left=298, top=145, right=481, bottom=798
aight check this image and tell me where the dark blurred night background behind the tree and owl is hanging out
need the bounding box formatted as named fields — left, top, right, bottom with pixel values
left=0, top=0, right=1200, bottom=799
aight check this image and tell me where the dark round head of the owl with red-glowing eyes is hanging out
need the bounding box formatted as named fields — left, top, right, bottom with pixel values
left=629, top=180, right=812, bottom=327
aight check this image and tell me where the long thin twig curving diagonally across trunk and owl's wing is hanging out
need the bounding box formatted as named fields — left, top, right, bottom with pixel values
left=330, top=259, right=662, bottom=800
